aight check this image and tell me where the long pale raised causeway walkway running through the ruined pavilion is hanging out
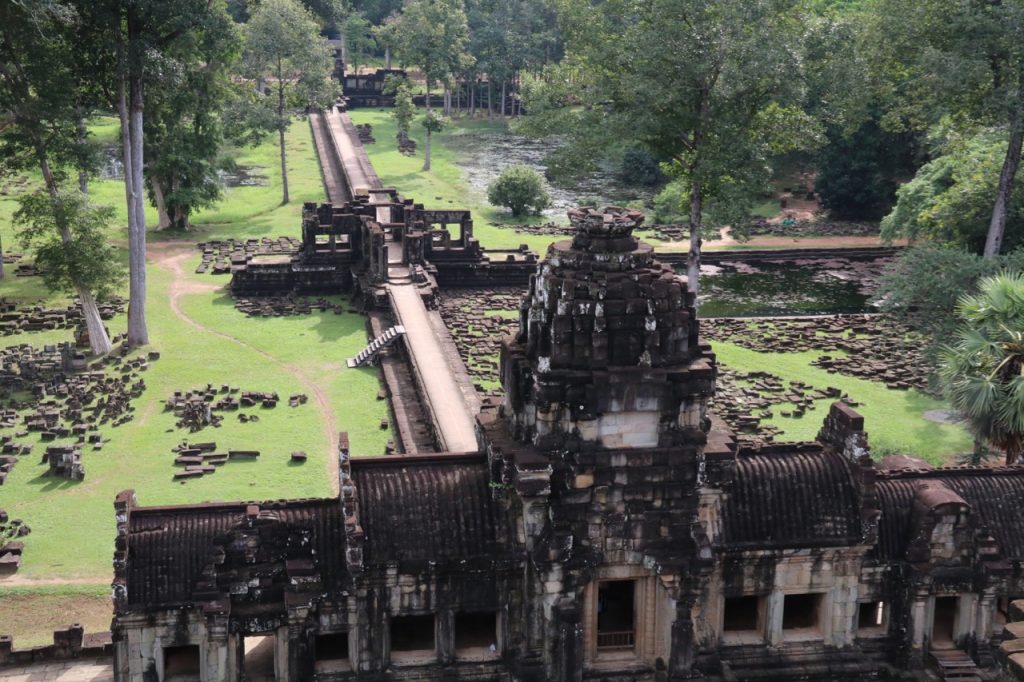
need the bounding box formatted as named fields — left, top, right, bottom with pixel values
left=310, top=111, right=478, bottom=453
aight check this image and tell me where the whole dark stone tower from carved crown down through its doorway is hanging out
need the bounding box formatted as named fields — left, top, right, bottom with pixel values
left=480, top=208, right=731, bottom=680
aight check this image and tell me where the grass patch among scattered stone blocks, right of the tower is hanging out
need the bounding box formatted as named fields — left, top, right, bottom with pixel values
left=712, top=341, right=972, bottom=465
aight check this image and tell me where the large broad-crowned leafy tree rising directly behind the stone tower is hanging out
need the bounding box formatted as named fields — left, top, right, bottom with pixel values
left=520, top=0, right=819, bottom=303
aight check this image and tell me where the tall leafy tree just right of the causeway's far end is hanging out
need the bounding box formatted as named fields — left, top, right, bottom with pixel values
left=378, top=0, right=473, bottom=112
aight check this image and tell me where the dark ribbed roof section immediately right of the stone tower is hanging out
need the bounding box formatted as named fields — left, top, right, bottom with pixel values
left=721, top=444, right=861, bottom=549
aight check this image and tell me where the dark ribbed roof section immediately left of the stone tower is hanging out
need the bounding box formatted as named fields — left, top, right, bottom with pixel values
left=351, top=455, right=507, bottom=563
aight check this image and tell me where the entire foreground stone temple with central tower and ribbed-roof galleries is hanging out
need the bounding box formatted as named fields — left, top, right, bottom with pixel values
left=113, top=209, right=1024, bottom=682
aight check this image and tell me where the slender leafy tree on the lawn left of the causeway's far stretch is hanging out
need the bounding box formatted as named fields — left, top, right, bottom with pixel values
left=244, top=0, right=338, bottom=204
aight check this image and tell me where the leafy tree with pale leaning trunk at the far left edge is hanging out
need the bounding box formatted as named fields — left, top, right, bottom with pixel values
left=0, top=2, right=111, bottom=354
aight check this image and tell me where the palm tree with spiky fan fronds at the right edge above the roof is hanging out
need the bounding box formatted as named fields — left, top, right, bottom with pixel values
left=939, top=272, right=1024, bottom=464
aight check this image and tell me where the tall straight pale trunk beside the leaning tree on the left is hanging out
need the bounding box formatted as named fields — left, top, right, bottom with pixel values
left=128, top=68, right=150, bottom=347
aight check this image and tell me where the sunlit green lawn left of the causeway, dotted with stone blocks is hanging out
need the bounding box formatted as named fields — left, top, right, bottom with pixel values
left=0, top=114, right=391, bottom=646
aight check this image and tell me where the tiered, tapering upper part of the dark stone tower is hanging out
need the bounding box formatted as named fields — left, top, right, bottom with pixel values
left=502, top=208, right=714, bottom=450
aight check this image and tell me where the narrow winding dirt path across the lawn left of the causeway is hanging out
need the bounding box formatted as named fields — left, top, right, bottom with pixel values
left=148, top=242, right=339, bottom=494
